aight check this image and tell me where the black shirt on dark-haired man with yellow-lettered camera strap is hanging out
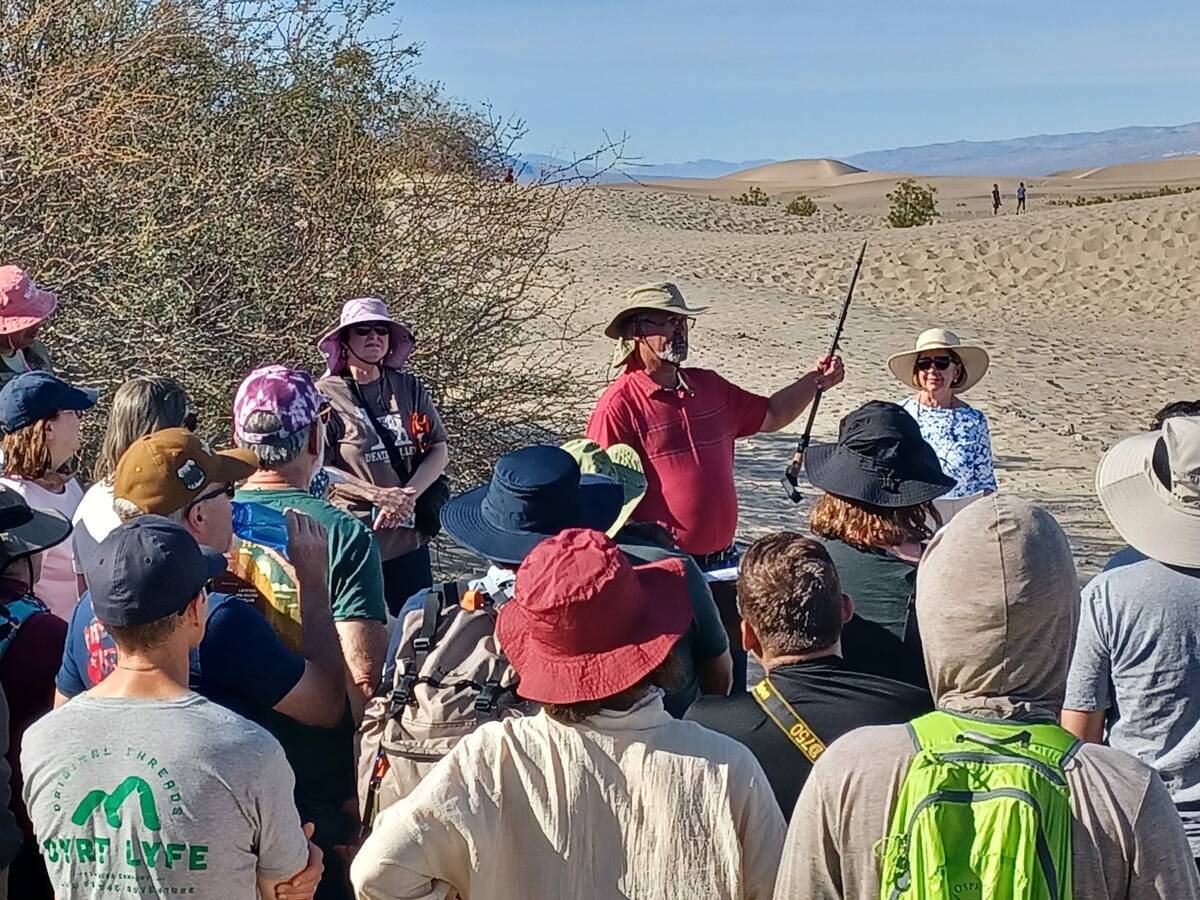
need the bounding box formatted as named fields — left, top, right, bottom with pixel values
left=684, top=656, right=934, bottom=818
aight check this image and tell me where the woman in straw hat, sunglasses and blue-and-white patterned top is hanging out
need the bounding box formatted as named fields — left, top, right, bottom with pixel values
left=888, top=328, right=996, bottom=521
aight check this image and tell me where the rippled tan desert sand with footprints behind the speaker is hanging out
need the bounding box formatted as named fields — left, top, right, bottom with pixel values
left=560, top=157, right=1200, bottom=576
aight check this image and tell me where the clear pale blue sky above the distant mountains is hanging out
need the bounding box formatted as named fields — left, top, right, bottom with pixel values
left=391, top=0, right=1200, bottom=162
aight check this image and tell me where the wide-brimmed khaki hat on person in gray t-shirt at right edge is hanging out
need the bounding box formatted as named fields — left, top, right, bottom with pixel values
left=1096, top=416, right=1200, bottom=569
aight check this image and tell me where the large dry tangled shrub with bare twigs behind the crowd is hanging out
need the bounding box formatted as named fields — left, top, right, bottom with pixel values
left=0, top=0, right=617, bottom=485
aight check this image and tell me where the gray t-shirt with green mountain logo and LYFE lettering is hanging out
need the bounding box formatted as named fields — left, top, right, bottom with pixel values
left=20, top=694, right=308, bottom=900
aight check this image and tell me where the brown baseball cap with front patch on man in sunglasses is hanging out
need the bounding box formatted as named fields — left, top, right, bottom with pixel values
left=113, top=428, right=258, bottom=516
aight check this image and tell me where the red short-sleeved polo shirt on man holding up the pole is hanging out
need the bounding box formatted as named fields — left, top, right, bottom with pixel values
left=587, top=368, right=767, bottom=556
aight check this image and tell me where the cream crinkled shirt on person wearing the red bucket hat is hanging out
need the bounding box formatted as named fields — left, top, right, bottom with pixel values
left=350, top=691, right=785, bottom=900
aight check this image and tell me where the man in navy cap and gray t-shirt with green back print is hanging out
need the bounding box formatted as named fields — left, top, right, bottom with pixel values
left=22, top=516, right=323, bottom=898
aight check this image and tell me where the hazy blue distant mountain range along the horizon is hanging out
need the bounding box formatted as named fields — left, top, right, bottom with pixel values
left=517, top=122, right=1200, bottom=184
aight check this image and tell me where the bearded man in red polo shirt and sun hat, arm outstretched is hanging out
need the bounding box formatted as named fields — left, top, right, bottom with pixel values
left=587, top=282, right=844, bottom=690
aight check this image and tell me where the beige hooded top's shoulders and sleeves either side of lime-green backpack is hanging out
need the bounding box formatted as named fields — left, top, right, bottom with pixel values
left=775, top=725, right=1200, bottom=900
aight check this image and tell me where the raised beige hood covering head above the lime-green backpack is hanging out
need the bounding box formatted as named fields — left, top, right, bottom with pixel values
left=917, top=494, right=1079, bottom=720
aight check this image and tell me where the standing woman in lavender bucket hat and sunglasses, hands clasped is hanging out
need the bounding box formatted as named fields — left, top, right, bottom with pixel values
left=317, top=298, right=449, bottom=616
